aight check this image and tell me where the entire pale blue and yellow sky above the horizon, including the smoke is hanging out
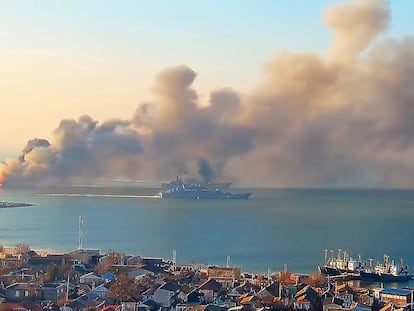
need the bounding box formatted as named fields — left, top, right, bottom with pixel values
left=0, top=0, right=414, bottom=187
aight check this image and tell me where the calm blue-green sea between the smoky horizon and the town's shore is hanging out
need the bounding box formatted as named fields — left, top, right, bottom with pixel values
left=0, top=186, right=414, bottom=286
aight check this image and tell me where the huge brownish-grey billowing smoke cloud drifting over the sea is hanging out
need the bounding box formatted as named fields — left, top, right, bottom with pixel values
left=0, top=0, right=414, bottom=187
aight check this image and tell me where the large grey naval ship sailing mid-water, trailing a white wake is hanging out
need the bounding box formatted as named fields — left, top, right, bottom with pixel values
left=159, top=177, right=252, bottom=200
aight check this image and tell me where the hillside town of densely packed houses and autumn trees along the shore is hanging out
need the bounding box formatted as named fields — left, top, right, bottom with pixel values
left=0, top=244, right=413, bottom=311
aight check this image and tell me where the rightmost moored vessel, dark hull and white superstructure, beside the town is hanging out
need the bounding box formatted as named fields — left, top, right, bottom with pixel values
left=360, top=254, right=413, bottom=282
